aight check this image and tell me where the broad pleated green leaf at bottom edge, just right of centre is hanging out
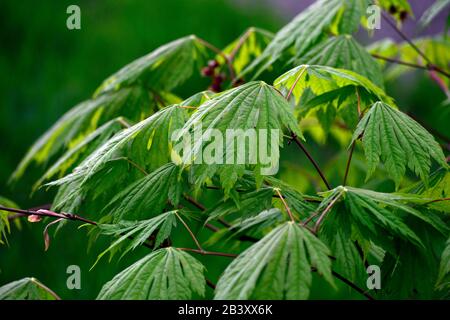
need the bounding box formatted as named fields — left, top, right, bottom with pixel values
left=214, top=222, right=333, bottom=300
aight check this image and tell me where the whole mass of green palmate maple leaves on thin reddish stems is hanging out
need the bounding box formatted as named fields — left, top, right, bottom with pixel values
left=0, top=0, right=450, bottom=299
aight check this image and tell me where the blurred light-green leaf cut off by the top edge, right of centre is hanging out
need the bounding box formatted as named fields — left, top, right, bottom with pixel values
left=242, top=0, right=367, bottom=79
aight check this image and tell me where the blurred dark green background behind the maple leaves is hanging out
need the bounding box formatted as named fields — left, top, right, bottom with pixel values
left=0, top=0, right=450, bottom=299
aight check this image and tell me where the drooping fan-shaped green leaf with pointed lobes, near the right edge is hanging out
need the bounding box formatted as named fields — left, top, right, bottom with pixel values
left=352, top=102, right=447, bottom=186
